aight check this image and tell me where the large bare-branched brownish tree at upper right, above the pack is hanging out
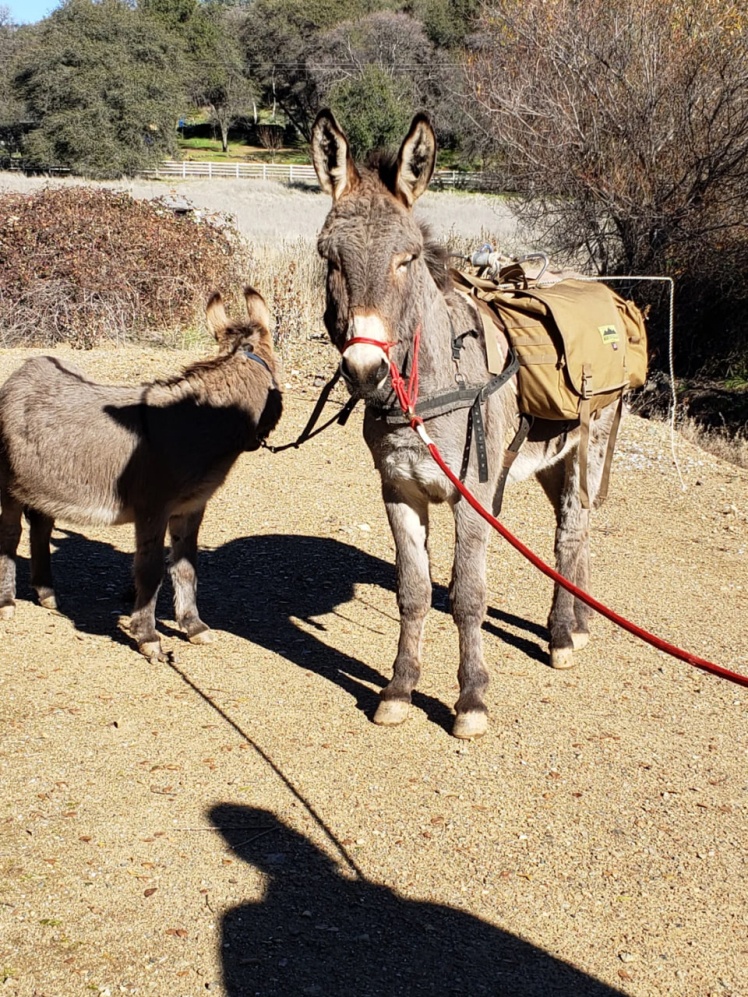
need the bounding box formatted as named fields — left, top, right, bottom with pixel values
left=466, top=0, right=748, bottom=372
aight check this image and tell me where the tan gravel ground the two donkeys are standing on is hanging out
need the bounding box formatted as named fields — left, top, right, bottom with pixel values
left=0, top=343, right=748, bottom=997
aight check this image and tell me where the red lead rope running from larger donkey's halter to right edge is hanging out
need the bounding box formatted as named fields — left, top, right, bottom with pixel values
left=380, top=325, right=748, bottom=688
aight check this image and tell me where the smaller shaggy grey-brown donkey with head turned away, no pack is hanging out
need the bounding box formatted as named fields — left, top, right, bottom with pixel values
left=0, top=287, right=282, bottom=662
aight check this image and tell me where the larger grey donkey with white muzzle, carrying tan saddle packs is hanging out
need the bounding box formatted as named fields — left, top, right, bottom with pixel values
left=312, top=111, right=616, bottom=738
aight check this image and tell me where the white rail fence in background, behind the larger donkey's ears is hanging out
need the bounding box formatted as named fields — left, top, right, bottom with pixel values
left=140, top=159, right=498, bottom=190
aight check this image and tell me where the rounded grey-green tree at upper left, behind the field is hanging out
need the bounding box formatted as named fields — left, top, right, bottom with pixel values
left=15, top=0, right=182, bottom=176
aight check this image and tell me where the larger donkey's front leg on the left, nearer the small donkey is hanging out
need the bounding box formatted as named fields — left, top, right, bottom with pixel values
left=374, top=486, right=431, bottom=726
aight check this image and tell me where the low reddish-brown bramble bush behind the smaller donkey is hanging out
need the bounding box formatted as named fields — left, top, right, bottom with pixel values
left=0, top=187, right=251, bottom=348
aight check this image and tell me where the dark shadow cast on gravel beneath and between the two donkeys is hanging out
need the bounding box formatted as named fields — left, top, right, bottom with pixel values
left=27, top=530, right=547, bottom=730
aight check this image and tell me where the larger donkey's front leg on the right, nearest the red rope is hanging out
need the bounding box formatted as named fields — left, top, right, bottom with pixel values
left=449, top=501, right=489, bottom=738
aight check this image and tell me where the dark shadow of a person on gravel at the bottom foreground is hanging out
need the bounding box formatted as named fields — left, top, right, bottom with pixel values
left=208, top=803, right=621, bottom=997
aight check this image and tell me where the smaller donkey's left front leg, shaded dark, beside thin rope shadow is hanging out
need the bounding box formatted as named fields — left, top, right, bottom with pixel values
left=130, top=514, right=166, bottom=662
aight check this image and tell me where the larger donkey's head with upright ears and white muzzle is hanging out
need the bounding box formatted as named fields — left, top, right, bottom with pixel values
left=312, top=111, right=446, bottom=397
